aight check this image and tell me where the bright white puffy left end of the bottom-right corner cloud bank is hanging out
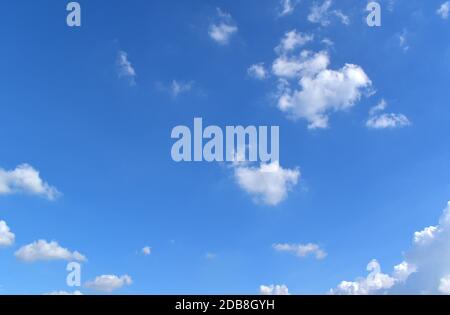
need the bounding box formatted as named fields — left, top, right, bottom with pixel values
left=331, top=260, right=396, bottom=295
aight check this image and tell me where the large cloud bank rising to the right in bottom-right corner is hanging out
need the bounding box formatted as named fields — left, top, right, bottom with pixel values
left=330, top=201, right=450, bottom=295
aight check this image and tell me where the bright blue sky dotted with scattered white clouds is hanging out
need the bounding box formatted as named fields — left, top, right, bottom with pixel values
left=0, top=0, right=450, bottom=294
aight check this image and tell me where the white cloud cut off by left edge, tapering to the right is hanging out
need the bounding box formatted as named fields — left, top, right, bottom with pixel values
left=0, top=164, right=60, bottom=200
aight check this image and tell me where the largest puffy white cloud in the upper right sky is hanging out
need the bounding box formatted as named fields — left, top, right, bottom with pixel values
left=273, top=51, right=372, bottom=129
